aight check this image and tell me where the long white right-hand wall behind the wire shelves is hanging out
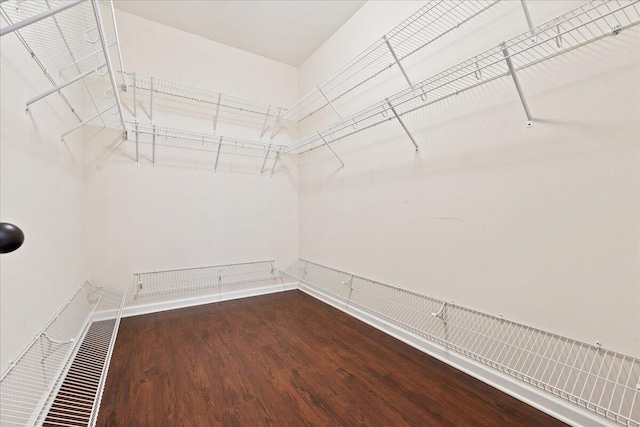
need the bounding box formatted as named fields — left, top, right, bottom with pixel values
left=299, top=2, right=640, bottom=355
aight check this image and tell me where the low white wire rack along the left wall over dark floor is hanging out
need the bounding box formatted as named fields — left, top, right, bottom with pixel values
left=0, top=282, right=125, bottom=427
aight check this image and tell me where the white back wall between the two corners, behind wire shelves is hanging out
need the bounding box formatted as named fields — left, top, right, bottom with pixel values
left=86, top=11, right=298, bottom=298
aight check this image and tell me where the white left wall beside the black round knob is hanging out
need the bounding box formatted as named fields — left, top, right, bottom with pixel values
left=0, top=35, right=87, bottom=372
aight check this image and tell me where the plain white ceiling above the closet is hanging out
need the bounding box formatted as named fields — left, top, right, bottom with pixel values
left=114, top=0, right=366, bottom=67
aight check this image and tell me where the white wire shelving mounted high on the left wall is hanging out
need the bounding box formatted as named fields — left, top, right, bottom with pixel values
left=0, top=0, right=126, bottom=139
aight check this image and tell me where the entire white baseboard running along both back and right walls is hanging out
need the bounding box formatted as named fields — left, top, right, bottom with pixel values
left=119, top=282, right=618, bottom=427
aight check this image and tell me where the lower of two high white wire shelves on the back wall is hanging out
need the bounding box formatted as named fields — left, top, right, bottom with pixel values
left=129, top=123, right=286, bottom=174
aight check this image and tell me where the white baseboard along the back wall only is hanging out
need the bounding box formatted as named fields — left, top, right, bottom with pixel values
left=122, top=282, right=298, bottom=317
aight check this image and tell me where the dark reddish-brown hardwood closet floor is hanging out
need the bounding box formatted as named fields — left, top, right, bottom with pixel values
left=98, top=291, right=565, bottom=427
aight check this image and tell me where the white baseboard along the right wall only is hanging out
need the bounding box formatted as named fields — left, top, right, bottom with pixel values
left=298, top=284, right=619, bottom=427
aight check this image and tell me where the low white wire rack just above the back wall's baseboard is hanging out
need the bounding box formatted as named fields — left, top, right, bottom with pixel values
left=133, top=261, right=280, bottom=299
